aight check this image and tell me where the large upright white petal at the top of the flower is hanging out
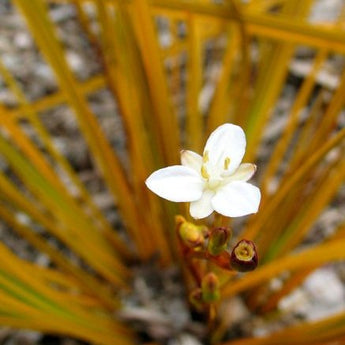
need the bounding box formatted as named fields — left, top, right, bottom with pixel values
left=204, top=123, right=246, bottom=174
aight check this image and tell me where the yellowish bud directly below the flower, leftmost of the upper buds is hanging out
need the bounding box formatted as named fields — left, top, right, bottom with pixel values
left=176, top=216, right=207, bottom=248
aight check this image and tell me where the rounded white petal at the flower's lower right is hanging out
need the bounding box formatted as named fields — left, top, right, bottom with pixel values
left=212, top=181, right=261, bottom=217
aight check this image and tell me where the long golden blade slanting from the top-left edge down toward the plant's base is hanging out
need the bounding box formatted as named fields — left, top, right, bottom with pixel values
left=12, top=0, right=145, bottom=253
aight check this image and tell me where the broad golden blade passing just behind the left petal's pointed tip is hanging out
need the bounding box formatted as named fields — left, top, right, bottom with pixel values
left=93, top=0, right=171, bottom=262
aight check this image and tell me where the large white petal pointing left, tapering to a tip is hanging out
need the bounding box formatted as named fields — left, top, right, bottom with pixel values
left=145, top=165, right=203, bottom=202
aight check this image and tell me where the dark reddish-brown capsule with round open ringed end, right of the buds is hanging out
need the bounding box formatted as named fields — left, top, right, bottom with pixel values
left=231, top=240, right=258, bottom=272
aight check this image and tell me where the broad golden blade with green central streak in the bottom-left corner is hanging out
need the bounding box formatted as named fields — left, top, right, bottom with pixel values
left=0, top=245, right=134, bottom=343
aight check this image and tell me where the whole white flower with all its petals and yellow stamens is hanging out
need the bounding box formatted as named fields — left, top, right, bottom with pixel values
left=146, top=123, right=261, bottom=219
